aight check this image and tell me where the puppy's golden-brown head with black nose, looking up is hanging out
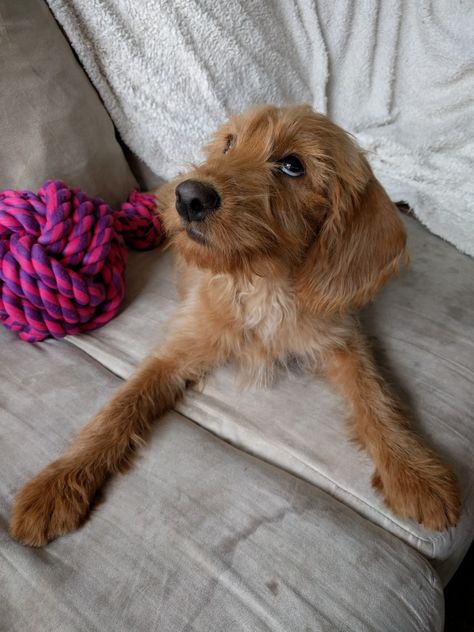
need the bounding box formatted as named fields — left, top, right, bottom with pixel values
left=160, top=106, right=405, bottom=312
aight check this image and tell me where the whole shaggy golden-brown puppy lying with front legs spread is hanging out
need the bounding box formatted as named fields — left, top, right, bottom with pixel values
left=11, top=106, right=459, bottom=546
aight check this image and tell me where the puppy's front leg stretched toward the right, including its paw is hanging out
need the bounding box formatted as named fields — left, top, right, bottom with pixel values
left=324, top=334, right=459, bottom=530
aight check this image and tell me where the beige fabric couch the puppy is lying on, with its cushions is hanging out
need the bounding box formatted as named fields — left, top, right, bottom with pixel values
left=0, top=0, right=474, bottom=632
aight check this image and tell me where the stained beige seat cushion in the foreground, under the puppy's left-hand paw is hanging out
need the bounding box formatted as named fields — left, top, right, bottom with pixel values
left=0, top=329, right=443, bottom=632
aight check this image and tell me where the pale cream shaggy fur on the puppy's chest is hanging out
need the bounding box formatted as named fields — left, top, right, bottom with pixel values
left=181, top=266, right=348, bottom=383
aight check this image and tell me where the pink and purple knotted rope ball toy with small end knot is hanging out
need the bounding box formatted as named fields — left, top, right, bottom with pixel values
left=0, top=180, right=161, bottom=342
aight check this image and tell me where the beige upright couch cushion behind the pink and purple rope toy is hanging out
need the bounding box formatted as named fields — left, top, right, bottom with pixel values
left=0, top=0, right=136, bottom=205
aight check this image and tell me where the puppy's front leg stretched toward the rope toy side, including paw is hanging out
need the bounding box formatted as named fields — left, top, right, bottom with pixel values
left=10, top=323, right=223, bottom=546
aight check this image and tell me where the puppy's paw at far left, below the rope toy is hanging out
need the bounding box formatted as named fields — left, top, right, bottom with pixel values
left=10, top=460, right=92, bottom=546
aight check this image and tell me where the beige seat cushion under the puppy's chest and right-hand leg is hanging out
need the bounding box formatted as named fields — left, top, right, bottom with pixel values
left=65, top=219, right=474, bottom=582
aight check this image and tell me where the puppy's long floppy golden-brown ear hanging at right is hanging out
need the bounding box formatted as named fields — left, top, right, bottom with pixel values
left=297, top=168, right=408, bottom=313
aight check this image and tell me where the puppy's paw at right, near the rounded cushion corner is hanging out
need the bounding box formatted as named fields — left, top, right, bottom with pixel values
left=372, top=458, right=460, bottom=531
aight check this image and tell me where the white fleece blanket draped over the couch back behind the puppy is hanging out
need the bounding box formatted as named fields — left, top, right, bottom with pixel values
left=48, top=0, right=474, bottom=255
